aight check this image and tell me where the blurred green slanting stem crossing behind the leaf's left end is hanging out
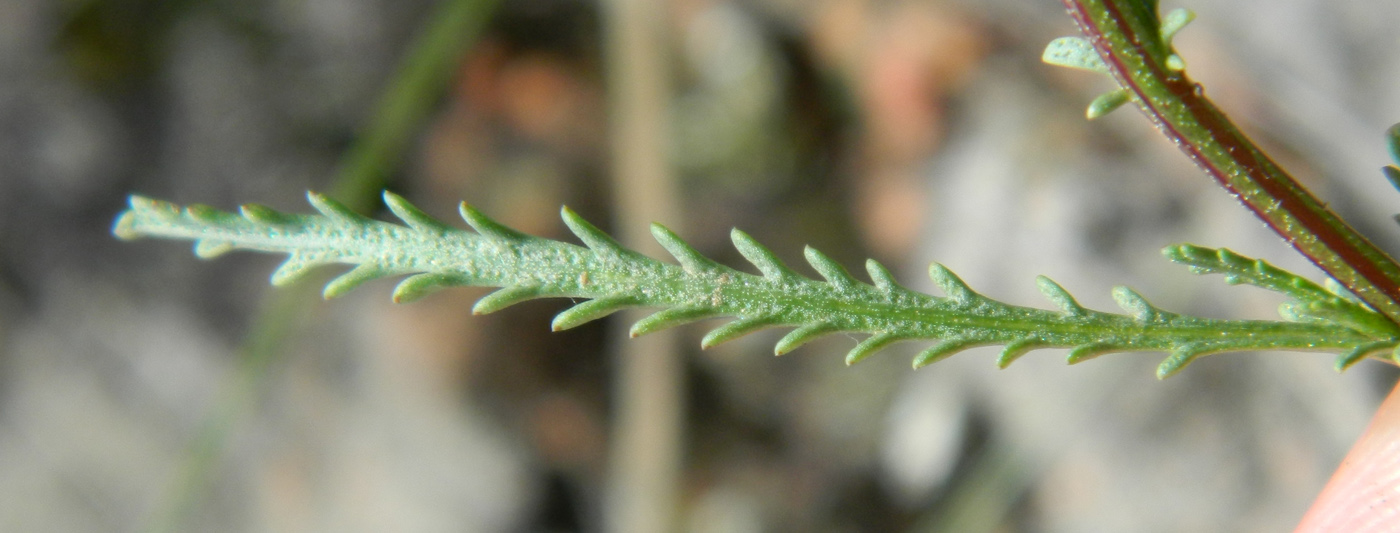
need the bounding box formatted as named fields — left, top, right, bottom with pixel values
left=147, top=0, right=498, bottom=532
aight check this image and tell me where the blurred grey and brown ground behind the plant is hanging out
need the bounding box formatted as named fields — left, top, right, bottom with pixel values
left=0, top=0, right=1400, bottom=532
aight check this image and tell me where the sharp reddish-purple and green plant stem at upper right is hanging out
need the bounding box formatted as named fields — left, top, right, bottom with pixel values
left=1064, top=0, right=1400, bottom=323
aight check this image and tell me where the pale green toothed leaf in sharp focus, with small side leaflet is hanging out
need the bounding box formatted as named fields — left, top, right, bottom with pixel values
left=113, top=193, right=1400, bottom=378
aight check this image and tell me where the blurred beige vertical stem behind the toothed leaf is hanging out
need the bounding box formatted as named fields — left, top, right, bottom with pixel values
left=603, top=0, right=685, bottom=533
